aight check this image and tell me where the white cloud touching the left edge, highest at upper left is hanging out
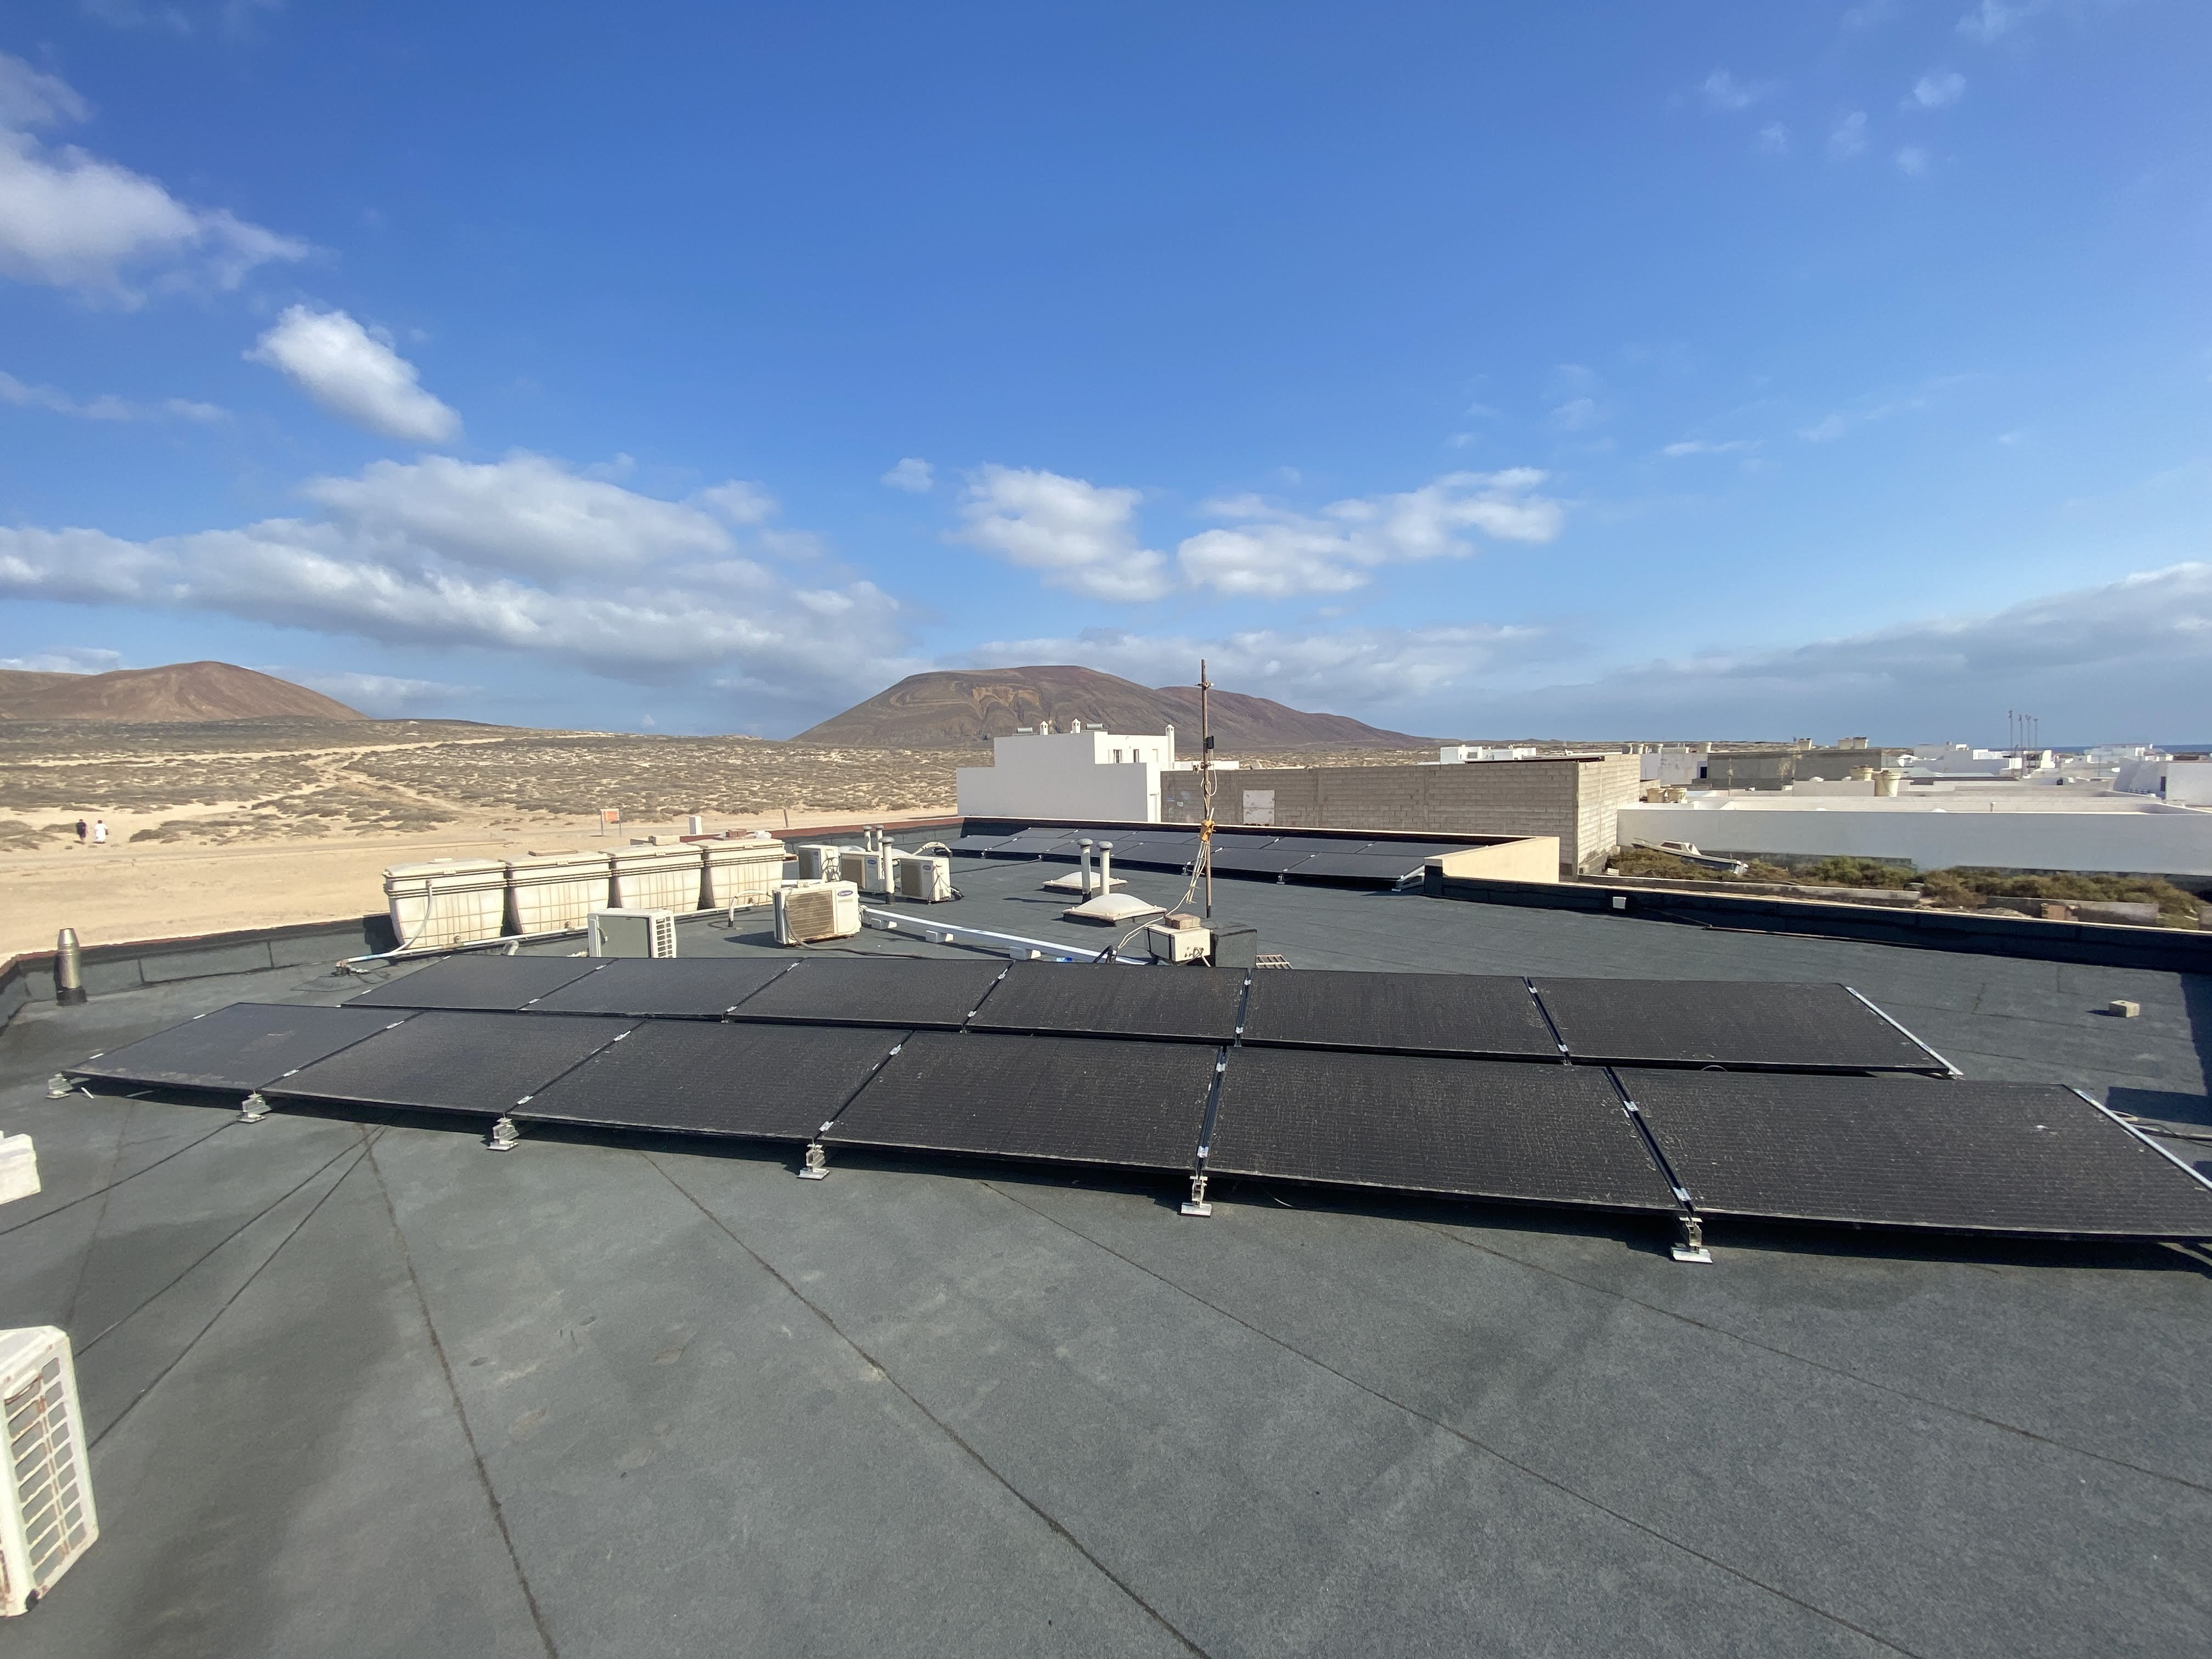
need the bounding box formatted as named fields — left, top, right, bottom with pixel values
left=0, top=53, right=307, bottom=305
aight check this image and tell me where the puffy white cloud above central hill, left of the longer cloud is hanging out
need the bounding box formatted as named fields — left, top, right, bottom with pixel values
left=956, top=467, right=1175, bottom=600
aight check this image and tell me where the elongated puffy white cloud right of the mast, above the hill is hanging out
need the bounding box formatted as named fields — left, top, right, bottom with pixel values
left=1177, top=467, right=1566, bottom=600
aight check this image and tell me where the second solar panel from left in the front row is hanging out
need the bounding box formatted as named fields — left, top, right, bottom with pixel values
left=261, top=1011, right=635, bottom=1117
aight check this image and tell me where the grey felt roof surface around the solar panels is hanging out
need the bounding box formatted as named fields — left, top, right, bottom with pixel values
left=0, top=858, right=2212, bottom=1659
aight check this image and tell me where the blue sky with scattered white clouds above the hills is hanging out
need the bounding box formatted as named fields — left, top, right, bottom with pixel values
left=0, top=0, right=2212, bottom=743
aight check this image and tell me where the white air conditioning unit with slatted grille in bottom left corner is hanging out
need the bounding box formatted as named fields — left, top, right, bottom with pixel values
left=0, top=1325, right=99, bottom=1615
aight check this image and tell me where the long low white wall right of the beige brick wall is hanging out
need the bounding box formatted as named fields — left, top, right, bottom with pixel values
left=1621, top=805, right=2212, bottom=876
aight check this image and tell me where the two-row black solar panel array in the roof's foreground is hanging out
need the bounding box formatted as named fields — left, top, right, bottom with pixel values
left=71, top=958, right=2212, bottom=1237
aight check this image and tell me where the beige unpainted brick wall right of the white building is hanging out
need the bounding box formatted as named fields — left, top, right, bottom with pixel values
left=1159, top=754, right=1639, bottom=874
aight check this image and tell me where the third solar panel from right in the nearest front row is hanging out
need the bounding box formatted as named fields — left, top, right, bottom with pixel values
left=823, top=1031, right=1219, bottom=1170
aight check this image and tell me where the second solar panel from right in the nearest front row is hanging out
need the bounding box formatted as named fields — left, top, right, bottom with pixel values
left=1205, top=1048, right=1679, bottom=1210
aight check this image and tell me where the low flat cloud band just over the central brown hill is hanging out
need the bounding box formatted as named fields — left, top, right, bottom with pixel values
left=962, top=624, right=1550, bottom=710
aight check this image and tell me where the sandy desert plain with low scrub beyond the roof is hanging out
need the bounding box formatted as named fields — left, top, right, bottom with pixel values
left=0, top=721, right=1425, bottom=956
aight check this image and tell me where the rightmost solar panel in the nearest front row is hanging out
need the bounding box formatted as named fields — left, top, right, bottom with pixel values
left=1621, top=1070, right=2212, bottom=1239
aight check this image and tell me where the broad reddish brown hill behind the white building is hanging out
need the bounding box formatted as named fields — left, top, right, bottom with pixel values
left=792, top=666, right=1429, bottom=752
